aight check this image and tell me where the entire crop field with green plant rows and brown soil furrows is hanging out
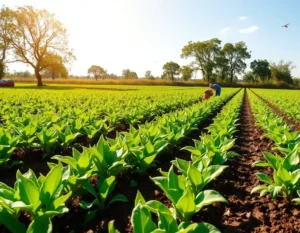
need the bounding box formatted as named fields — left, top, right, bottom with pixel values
left=0, top=84, right=300, bottom=233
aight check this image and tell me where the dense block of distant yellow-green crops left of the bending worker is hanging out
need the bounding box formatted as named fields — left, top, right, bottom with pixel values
left=0, top=89, right=210, bottom=167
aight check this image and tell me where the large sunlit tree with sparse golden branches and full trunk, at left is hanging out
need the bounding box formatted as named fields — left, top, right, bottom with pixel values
left=10, top=6, right=75, bottom=86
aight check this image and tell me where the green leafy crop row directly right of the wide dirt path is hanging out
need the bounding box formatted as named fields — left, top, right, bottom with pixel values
left=249, top=91, right=300, bottom=204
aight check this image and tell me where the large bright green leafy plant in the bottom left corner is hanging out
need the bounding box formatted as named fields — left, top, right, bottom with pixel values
left=0, top=164, right=72, bottom=233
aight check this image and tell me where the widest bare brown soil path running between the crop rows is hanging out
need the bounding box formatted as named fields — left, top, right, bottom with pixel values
left=194, top=89, right=300, bottom=233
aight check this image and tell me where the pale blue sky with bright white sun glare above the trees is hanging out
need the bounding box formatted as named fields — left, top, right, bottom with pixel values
left=1, top=0, right=300, bottom=77
